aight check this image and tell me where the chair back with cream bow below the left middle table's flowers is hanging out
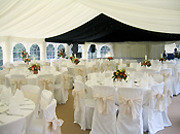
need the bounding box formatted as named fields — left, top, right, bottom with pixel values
left=37, top=74, right=54, bottom=93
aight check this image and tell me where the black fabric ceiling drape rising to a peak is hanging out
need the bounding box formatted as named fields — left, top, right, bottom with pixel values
left=45, top=14, right=180, bottom=44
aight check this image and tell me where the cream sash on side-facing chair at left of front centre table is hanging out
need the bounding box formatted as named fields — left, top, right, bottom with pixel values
left=72, top=89, right=84, bottom=111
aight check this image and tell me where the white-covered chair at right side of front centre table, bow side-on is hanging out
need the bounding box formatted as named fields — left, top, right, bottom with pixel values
left=143, top=82, right=166, bottom=134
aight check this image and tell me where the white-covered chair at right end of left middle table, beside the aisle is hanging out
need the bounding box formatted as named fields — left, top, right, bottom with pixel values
left=54, top=73, right=69, bottom=104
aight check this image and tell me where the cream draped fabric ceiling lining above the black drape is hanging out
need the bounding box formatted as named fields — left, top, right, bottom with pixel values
left=0, top=0, right=180, bottom=38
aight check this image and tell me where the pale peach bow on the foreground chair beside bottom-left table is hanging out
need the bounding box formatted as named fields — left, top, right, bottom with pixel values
left=46, top=118, right=64, bottom=134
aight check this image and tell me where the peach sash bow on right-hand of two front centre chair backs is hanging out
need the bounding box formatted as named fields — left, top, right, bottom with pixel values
left=119, top=95, right=143, bottom=119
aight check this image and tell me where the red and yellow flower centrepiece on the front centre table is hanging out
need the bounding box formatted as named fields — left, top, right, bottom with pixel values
left=112, top=69, right=127, bottom=81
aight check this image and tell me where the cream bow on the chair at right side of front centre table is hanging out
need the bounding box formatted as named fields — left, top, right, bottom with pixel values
left=155, top=93, right=166, bottom=112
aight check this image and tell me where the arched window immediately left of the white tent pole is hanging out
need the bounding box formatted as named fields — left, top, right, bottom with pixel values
left=30, top=44, right=40, bottom=60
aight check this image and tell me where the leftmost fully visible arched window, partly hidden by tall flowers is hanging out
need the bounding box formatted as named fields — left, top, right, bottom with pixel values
left=13, top=43, right=26, bottom=61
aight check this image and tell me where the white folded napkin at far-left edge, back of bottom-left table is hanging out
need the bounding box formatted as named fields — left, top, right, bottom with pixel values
left=1, top=88, right=12, bottom=105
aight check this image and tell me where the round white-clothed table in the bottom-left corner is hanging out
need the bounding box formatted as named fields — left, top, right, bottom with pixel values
left=0, top=98, right=35, bottom=134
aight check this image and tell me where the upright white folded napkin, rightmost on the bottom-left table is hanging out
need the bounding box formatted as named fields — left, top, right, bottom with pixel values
left=9, top=96, right=20, bottom=114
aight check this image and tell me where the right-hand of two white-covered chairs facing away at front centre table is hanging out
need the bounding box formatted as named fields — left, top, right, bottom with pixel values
left=116, top=87, right=143, bottom=134
